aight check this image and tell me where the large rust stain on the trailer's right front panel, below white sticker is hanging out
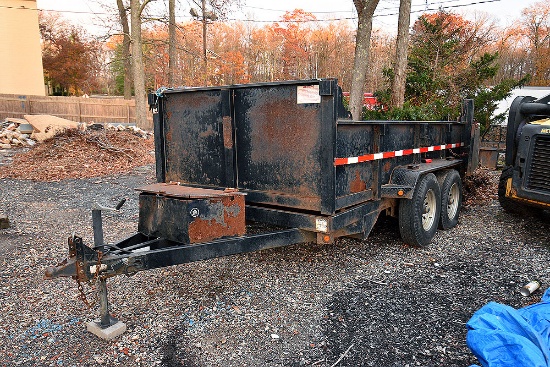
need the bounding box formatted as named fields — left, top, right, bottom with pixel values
left=247, top=95, right=323, bottom=196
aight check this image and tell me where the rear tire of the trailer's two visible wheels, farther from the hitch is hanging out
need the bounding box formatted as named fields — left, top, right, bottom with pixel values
left=437, top=169, right=462, bottom=229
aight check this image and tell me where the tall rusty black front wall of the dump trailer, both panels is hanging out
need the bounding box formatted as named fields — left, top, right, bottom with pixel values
left=156, top=80, right=338, bottom=213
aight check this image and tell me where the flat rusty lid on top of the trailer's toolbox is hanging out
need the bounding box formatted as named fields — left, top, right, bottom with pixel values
left=136, top=183, right=246, bottom=199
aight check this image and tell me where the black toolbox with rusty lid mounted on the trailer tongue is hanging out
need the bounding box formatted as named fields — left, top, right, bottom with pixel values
left=138, top=184, right=246, bottom=243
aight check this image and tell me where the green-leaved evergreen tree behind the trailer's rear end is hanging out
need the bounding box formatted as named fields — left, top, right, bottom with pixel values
left=374, top=11, right=528, bottom=132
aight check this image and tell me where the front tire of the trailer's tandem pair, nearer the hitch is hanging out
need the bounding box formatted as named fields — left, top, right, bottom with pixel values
left=399, top=173, right=441, bottom=247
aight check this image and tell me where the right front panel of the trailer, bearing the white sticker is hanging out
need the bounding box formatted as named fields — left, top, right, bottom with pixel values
left=233, top=84, right=331, bottom=210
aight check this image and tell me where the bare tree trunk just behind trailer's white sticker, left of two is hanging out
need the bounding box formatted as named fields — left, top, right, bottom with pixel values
left=349, top=0, right=379, bottom=120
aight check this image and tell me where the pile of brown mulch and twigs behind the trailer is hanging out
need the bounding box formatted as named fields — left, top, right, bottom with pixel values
left=0, top=129, right=155, bottom=181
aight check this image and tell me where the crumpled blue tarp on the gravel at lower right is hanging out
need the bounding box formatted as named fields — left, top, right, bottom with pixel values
left=466, top=289, right=550, bottom=367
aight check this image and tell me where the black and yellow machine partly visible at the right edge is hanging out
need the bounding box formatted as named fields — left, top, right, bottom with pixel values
left=498, top=94, right=550, bottom=214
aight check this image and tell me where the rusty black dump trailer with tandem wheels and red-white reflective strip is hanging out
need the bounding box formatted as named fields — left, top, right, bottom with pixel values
left=46, top=79, right=479, bottom=334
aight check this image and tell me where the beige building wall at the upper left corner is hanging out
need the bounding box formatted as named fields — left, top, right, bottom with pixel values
left=0, top=0, right=45, bottom=96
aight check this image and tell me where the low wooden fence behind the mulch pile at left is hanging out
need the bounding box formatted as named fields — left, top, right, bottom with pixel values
left=0, top=94, right=153, bottom=129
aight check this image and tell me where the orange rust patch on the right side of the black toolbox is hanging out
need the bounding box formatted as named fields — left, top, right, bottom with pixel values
left=189, top=195, right=246, bottom=243
